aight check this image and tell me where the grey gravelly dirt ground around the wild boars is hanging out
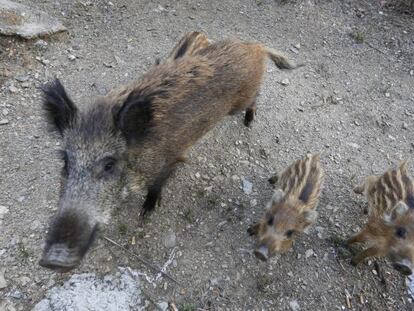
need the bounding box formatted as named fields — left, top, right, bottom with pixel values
left=0, top=0, right=414, bottom=311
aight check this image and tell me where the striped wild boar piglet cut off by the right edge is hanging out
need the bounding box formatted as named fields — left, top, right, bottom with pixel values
left=347, top=161, right=414, bottom=272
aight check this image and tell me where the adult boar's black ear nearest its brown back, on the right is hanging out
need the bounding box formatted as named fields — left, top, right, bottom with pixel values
left=112, top=92, right=153, bottom=143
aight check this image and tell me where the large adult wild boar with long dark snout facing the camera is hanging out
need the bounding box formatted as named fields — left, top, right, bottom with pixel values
left=40, top=31, right=295, bottom=271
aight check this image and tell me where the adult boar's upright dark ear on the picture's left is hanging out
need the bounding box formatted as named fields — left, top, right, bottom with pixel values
left=42, top=79, right=78, bottom=134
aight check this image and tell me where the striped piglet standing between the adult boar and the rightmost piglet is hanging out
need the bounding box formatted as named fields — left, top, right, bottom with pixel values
left=249, top=154, right=323, bottom=258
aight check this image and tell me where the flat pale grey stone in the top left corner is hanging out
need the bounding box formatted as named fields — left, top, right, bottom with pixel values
left=0, top=0, right=67, bottom=39
